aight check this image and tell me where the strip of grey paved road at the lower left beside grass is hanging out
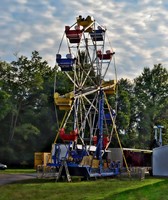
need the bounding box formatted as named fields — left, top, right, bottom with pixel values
left=0, top=174, right=37, bottom=185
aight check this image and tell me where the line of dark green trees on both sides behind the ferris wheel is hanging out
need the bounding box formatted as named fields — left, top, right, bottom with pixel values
left=0, top=51, right=168, bottom=166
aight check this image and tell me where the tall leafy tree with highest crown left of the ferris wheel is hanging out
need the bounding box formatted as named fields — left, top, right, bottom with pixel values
left=7, top=51, right=47, bottom=140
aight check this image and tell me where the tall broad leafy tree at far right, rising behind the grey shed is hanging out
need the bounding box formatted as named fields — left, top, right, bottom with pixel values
left=134, top=64, right=168, bottom=147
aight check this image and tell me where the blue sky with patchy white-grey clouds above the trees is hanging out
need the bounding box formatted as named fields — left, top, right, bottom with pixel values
left=0, top=0, right=168, bottom=79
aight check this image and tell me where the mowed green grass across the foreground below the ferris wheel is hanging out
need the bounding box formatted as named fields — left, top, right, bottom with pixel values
left=0, top=171, right=168, bottom=200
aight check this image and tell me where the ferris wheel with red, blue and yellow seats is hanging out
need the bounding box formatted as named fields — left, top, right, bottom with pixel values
left=51, top=16, right=117, bottom=178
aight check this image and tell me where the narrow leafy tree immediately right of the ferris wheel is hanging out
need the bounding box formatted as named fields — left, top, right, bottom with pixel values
left=116, top=79, right=137, bottom=147
